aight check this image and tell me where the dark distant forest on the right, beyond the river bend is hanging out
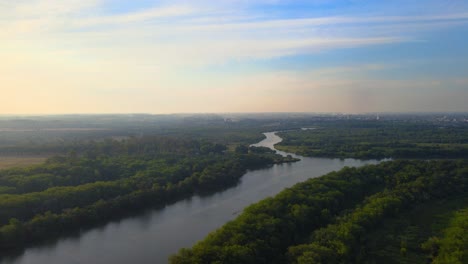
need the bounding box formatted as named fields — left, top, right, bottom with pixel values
left=277, top=120, right=468, bottom=159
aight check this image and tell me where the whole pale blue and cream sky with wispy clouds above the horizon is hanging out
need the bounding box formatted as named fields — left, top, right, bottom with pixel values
left=0, top=0, right=468, bottom=114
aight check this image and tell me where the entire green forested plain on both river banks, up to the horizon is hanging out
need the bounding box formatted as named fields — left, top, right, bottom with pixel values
left=0, top=115, right=468, bottom=264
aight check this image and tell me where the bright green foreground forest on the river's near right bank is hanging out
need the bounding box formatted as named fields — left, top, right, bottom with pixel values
left=170, top=160, right=468, bottom=263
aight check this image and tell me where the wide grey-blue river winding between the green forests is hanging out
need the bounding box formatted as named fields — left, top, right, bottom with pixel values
left=0, top=132, right=377, bottom=264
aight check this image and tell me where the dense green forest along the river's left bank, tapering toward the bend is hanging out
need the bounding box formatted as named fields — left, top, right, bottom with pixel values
left=0, top=136, right=294, bottom=252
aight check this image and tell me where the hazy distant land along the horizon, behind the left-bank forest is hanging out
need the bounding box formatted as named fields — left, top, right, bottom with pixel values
left=0, top=114, right=315, bottom=156
